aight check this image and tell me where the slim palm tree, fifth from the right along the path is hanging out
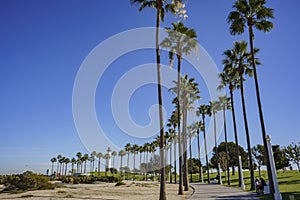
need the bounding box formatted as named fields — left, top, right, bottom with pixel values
left=209, top=101, right=222, bottom=184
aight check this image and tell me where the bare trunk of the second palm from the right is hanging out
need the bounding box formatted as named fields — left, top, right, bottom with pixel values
left=240, top=76, right=255, bottom=190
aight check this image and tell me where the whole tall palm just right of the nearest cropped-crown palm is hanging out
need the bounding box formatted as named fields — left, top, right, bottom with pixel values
left=161, top=22, right=198, bottom=195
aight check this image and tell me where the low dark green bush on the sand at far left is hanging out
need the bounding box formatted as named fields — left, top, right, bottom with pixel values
left=4, top=171, right=54, bottom=191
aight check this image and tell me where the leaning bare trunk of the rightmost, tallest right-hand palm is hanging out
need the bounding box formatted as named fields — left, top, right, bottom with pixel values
left=249, top=25, right=274, bottom=194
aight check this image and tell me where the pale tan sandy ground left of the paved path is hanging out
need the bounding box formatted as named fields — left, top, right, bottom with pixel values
left=0, top=181, right=193, bottom=200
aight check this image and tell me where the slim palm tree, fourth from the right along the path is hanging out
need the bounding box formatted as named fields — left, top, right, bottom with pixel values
left=216, top=95, right=231, bottom=185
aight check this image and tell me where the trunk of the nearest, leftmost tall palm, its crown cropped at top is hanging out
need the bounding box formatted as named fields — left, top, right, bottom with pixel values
left=155, top=0, right=167, bottom=200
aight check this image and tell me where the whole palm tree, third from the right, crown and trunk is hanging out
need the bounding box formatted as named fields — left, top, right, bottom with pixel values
left=218, top=69, right=242, bottom=187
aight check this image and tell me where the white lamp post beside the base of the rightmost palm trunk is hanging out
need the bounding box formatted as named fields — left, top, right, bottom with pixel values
left=266, top=135, right=282, bottom=200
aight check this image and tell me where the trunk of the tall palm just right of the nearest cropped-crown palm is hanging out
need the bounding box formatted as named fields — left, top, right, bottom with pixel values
left=177, top=58, right=183, bottom=195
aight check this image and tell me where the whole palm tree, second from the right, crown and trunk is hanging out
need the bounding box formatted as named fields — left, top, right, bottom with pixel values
left=223, top=41, right=255, bottom=190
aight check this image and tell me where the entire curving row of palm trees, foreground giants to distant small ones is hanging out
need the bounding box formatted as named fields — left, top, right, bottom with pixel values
left=51, top=0, right=273, bottom=200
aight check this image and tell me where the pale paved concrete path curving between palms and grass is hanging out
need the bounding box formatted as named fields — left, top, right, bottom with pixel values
left=190, top=183, right=258, bottom=200
